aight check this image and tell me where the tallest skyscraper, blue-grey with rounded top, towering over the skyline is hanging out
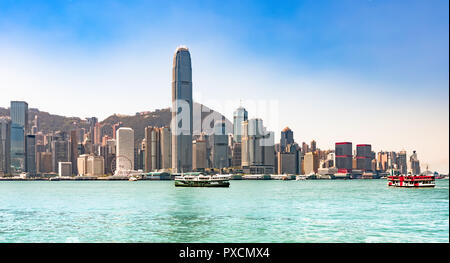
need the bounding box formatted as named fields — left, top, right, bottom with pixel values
left=171, top=46, right=193, bottom=172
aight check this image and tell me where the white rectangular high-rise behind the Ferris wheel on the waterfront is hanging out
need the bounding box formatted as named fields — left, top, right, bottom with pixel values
left=116, top=127, right=134, bottom=175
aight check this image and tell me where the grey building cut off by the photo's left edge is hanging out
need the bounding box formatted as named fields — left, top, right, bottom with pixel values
left=0, top=117, right=11, bottom=176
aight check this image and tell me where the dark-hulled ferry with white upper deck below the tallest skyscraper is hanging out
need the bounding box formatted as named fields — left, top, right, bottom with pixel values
left=175, top=174, right=230, bottom=187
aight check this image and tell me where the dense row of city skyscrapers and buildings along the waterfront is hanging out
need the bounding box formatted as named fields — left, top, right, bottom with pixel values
left=0, top=47, right=421, bottom=177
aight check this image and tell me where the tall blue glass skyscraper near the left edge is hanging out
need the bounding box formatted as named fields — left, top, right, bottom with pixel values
left=10, top=101, right=28, bottom=173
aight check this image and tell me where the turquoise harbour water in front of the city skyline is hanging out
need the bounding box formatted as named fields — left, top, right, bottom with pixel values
left=0, top=180, right=449, bottom=243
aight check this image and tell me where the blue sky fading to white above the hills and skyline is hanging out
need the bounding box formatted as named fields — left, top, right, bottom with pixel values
left=0, top=0, right=449, bottom=170
